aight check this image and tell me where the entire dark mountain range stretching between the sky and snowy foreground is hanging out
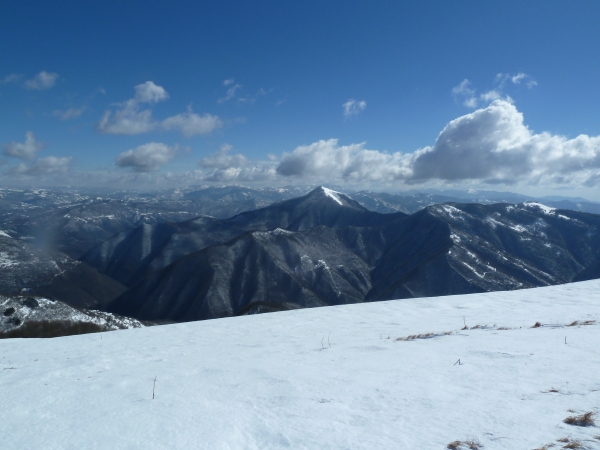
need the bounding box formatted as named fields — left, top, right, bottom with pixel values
left=0, top=186, right=600, bottom=321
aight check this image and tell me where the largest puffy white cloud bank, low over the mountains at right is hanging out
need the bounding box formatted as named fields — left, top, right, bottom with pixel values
left=277, top=100, right=600, bottom=185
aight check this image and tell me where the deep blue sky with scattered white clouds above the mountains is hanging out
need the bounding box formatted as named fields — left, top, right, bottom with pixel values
left=0, top=0, right=600, bottom=200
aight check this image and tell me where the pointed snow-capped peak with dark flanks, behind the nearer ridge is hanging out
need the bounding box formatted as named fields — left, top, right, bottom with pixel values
left=81, top=188, right=405, bottom=286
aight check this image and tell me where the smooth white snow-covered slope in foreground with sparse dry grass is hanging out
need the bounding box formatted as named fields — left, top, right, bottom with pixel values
left=0, top=280, right=600, bottom=449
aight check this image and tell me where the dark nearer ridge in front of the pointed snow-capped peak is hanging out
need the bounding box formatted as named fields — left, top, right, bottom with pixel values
left=108, top=203, right=600, bottom=321
